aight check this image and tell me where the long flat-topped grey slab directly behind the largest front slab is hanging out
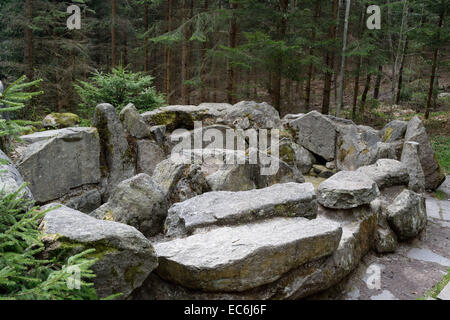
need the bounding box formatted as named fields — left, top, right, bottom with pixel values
left=166, top=183, right=317, bottom=236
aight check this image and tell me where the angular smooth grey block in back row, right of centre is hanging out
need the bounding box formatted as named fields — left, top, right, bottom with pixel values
left=289, top=111, right=336, bottom=161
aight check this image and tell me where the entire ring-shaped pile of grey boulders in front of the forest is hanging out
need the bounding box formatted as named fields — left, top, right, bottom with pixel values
left=0, top=101, right=444, bottom=299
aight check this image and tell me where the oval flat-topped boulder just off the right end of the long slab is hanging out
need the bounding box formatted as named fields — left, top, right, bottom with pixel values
left=317, top=171, right=380, bottom=209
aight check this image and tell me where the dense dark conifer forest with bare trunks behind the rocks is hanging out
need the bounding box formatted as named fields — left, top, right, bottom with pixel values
left=0, top=0, right=450, bottom=120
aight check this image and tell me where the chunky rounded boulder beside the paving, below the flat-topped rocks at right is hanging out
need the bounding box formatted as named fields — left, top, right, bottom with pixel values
left=387, top=190, right=427, bottom=240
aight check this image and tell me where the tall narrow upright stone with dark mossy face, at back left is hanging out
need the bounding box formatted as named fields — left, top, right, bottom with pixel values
left=92, top=103, right=136, bottom=200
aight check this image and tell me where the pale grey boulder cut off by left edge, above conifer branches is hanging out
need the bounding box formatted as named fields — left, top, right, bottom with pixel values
left=0, top=150, right=34, bottom=200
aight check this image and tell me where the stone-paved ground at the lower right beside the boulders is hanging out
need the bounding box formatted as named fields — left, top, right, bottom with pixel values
left=314, top=176, right=450, bottom=300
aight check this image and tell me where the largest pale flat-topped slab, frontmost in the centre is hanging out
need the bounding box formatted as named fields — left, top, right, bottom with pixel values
left=155, top=218, right=342, bottom=292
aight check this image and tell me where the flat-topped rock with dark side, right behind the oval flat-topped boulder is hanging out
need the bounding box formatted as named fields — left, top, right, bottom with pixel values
left=357, top=159, right=409, bottom=189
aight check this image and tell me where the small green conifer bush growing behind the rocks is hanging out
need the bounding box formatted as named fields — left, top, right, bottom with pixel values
left=74, top=67, right=165, bottom=116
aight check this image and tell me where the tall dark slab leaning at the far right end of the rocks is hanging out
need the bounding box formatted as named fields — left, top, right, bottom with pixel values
left=405, top=117, right=445, bottom=190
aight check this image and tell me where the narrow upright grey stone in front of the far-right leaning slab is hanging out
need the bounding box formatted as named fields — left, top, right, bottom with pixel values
left=401, top=141, right=425, bottom=193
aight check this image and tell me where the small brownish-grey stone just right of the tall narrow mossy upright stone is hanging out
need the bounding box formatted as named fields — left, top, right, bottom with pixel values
left=136, top=139, right=166, bottom=176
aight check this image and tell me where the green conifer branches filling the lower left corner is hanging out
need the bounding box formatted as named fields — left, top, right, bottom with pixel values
left=0, top=186, right=97, bottom=300
